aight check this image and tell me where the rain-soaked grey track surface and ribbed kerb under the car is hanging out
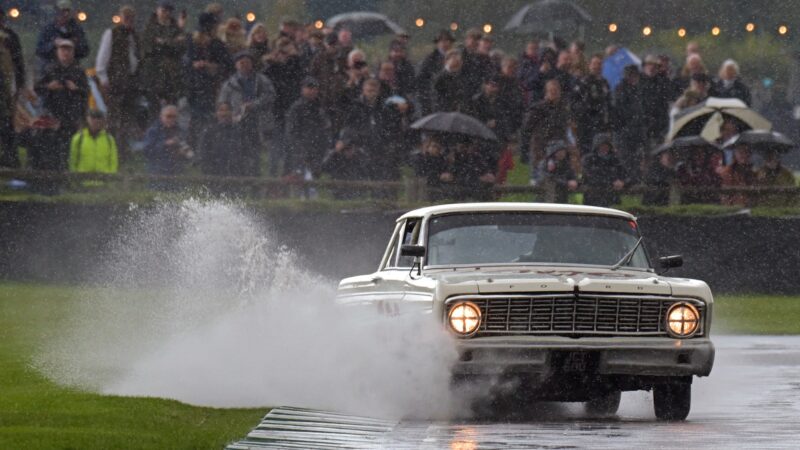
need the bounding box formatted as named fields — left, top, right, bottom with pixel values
left=231, top=336, right=800, bottom=450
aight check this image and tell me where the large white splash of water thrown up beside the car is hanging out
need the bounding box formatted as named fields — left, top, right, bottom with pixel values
left=36, top=200, right=456, bottom=417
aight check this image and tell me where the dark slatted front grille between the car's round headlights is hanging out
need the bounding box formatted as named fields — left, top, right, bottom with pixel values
left=447, top=293, right=705, bottom=336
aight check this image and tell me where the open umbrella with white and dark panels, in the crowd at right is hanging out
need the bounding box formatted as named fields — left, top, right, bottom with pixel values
left=667, top=97, right=772, bottom=141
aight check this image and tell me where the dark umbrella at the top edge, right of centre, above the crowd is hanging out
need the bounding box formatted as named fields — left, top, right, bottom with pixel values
left=504, top=0, right=592, bottom=34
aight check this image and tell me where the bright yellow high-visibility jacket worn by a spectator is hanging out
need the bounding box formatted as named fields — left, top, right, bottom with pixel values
left=69, top=128, right=119, bottom=173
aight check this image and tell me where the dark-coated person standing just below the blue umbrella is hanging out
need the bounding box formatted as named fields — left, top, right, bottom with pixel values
left=614, top=65, right=648, bottom=184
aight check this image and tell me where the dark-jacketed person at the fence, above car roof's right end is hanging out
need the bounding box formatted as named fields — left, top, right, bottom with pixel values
left=583, top=133, right=627, bottom=206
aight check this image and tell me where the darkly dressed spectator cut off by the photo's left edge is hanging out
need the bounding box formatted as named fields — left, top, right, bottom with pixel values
left=0, top=7, right=25, bottom=167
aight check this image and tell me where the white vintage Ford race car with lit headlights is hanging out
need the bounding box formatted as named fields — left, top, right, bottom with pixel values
left=337, top=203, right=714, bottom=420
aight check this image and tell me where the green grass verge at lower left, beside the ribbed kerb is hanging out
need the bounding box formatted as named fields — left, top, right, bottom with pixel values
left=0, top=284, right=267, bottom=449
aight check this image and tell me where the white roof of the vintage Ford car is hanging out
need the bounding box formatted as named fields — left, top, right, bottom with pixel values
left=397, top=202, right=636, bottom=221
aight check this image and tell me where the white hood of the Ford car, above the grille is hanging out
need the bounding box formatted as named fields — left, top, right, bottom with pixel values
left=427, top=267, right=672, bottom=295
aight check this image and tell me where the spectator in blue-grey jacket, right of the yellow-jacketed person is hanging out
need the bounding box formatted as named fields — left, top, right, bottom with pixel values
left=144, top=105, right=194, bottom=177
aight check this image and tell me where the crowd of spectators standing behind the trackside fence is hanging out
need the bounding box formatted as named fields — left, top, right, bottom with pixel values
left=0, top=0, right=794, bottom=205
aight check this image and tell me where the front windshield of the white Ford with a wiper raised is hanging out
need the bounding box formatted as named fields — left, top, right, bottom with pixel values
left=427, top=212, right=650, bottom=268
